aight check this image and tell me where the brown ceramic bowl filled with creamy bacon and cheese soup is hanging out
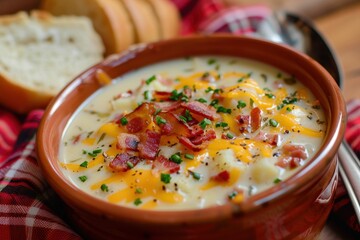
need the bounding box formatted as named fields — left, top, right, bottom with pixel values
left=37, top=35, right=346, bottom=239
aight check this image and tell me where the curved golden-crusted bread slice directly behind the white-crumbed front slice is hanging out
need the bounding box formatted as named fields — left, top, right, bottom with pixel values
left=41, top=0, right=135, bottom=55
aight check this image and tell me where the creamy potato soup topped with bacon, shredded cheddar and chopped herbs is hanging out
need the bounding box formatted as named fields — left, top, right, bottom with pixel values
left=60, top=56, right=326, bottom=210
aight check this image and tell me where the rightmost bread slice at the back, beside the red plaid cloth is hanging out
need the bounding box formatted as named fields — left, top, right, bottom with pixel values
left=147, top=0, right=181, bottom=39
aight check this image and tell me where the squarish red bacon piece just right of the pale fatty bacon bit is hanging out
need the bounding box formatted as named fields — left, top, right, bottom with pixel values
left=138, top=130, right=161, bottom=160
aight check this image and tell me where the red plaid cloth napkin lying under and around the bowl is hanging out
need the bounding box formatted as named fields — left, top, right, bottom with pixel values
left=0, top=0, right=360, bottom=240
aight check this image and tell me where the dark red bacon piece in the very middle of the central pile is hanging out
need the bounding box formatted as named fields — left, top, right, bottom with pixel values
left=158, top=112, right=192, bottom=137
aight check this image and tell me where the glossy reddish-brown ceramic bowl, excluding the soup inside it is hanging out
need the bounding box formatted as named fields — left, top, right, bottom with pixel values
left=37, top=35, right=346, bottom=239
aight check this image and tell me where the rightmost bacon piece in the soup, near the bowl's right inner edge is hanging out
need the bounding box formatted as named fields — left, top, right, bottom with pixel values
left=276, top=144, right=308, bottom=169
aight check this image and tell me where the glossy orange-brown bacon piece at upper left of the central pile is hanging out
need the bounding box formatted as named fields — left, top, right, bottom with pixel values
left=125, top=102, right=155, bottom=133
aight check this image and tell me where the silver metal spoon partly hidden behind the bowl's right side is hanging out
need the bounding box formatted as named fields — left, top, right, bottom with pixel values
left=256, top=12, right=360, bottom=222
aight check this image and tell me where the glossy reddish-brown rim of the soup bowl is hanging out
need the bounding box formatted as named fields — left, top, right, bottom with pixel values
left=36, top=34, right=346, bottom=224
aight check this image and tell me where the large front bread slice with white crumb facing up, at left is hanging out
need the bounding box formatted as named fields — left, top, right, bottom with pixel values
left=0, top=11, right=104, bottom=113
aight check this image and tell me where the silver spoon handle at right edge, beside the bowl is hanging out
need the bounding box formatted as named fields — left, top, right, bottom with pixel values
left=338, top=140, right=360, bottom=223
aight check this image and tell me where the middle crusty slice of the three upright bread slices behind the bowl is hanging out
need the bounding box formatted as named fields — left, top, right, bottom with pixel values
left=118, top=0, right=161, bottom=43
